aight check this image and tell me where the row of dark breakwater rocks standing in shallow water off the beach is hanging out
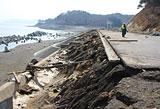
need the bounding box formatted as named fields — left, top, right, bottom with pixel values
left=0, top=31, right=69, bottom=52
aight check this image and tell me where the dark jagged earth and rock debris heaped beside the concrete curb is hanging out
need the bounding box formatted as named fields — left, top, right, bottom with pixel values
left=51, top=31, right=128, bottom=109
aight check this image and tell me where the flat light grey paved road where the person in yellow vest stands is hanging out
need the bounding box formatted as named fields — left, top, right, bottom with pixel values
left=100, top=30, right=160, bottom=68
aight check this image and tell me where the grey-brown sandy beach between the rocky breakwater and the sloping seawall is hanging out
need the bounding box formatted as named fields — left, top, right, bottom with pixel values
left=0, top=40, right=60, bottom=85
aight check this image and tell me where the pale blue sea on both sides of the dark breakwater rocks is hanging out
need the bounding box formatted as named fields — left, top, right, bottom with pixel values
left=0, top=20, right=66, bottom=52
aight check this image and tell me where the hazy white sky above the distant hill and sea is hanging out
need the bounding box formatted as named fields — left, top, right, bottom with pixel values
left=0, top=0, right=140, bottom=20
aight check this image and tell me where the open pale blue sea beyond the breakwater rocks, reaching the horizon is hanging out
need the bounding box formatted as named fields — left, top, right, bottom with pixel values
left=0, top=20, right=63, bottom=37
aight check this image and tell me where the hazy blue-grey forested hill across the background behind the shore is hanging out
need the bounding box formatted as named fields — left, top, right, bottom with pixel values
left=35, top=11, right=133, bottom=28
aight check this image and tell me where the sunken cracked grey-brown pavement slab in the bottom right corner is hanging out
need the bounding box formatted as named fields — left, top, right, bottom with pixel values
left=116, top=77, right=160, bottom=109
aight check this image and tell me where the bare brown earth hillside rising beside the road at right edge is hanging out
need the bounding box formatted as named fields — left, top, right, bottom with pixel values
left=127, top=4, right=160, bottom=33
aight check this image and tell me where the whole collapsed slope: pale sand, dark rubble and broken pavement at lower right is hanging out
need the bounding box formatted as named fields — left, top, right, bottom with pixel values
left=14, top=30, right=160, bottom=109
